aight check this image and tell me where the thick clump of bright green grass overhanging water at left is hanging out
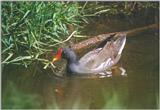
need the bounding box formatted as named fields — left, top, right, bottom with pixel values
left=2, top=1, right=84, bottom=68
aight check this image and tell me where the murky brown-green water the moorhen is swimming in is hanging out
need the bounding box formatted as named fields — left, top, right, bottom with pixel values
left=2, top=16, right=159, bottom=109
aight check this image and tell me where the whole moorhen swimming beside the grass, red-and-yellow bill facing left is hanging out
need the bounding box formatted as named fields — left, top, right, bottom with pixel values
left=53, top=34, right=126, bottom=74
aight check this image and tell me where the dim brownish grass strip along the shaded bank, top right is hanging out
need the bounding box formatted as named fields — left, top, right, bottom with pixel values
left=80, top=1, right=159, bottom=16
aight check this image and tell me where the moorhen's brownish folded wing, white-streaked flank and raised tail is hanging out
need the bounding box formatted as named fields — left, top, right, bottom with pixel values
left=79, top=34, right=126, bottom=70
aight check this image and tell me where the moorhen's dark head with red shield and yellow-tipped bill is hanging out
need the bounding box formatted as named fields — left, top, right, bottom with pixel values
left=52, top=48, right=77, bottom=62
